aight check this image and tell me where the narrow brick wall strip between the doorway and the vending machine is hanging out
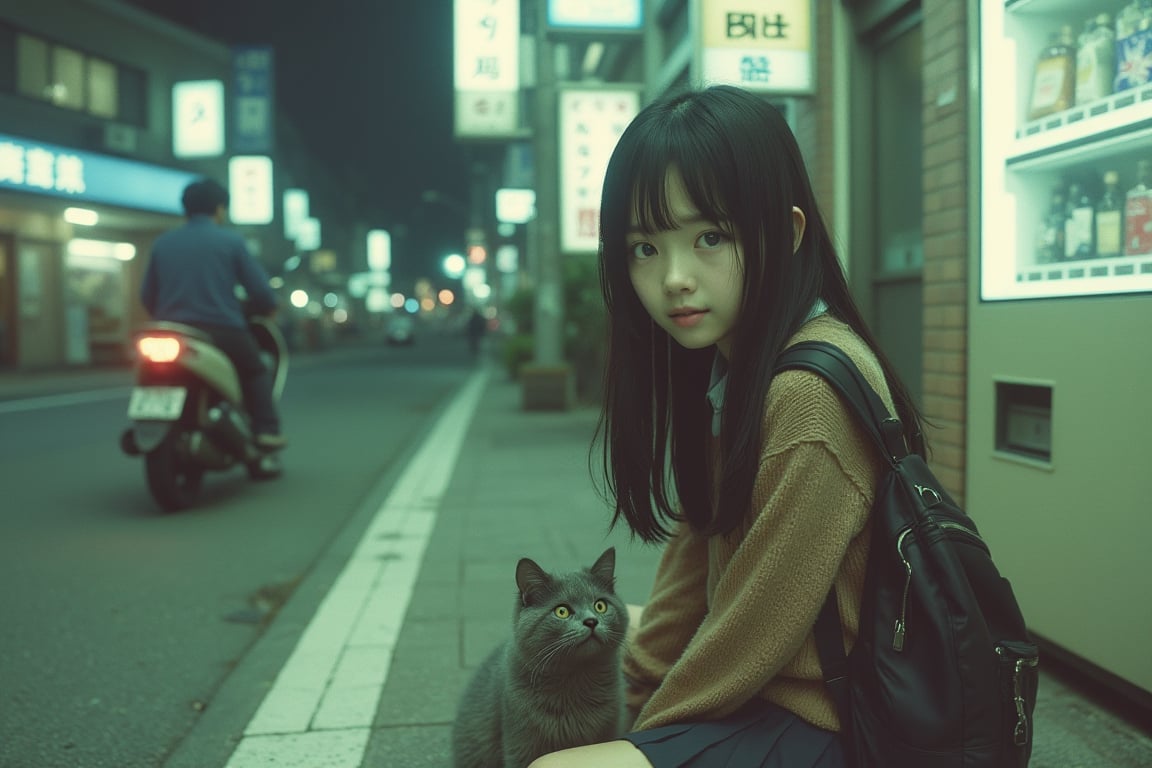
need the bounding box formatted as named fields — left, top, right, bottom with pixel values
left=922, top=0, right=970, bottom=503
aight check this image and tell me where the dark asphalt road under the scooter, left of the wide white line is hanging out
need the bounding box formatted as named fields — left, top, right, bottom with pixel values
left=0, top=336, right=475, bottom=768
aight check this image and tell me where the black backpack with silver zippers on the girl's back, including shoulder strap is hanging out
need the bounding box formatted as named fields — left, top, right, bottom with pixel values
left=776, top=342, right=1039, bottom=768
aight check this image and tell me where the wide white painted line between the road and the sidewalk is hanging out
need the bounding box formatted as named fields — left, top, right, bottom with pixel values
left=227, top=368, right=488, bottom=768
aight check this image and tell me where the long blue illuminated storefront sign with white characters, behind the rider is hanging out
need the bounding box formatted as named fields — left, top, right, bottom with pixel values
left=0, top=134, right=197, bottom=213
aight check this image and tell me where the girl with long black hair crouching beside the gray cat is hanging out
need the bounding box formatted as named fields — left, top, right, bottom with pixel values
left=532, top=86, right=919, bottom=768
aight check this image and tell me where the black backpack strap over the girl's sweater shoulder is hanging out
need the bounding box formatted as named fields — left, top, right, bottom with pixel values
left=775, top=341, right=908, bottom=461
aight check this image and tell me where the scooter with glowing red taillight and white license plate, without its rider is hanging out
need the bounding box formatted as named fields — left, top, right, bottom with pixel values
left=120, top=318, right=288, bottom=511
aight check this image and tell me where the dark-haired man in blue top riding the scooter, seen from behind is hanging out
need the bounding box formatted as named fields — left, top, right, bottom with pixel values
left=141, top=178, right=288, bottom=450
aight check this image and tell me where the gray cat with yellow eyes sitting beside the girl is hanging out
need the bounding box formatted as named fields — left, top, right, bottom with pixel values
left=452, top=547, right=628, bottom=768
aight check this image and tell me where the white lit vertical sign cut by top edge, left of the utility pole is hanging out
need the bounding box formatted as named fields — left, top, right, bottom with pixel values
left=454, top=0, right=520, bottom=138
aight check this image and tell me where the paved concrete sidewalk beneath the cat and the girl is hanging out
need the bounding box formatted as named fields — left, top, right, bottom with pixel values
left=362, top=374, right=1152, bottom=768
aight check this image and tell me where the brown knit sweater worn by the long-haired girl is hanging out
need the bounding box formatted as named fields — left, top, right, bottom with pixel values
left=624, top=315, right=892, bottom=730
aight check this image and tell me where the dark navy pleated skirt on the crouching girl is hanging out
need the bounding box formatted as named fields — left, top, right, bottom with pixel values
left=623, top=701, right=847, bottom=768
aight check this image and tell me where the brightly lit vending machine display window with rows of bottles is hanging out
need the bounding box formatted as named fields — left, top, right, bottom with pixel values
left=979, top=0, right=1152, bottom=301
